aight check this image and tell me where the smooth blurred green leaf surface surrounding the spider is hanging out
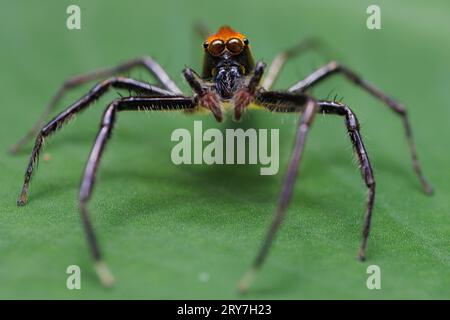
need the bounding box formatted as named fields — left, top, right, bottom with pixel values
left=0, top=0, right=450, bottom=299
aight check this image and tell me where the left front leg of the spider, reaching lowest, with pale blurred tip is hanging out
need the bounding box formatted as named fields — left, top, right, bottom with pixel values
left=79, top=96, right=196, bottom=286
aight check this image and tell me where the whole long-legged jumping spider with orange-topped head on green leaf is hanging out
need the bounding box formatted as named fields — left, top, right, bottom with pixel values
left=12, top=26, right=432, bottom=292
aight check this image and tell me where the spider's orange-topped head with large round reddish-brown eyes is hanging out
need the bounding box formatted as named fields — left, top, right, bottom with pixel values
left=203, top=26, right=254, bottom=91
